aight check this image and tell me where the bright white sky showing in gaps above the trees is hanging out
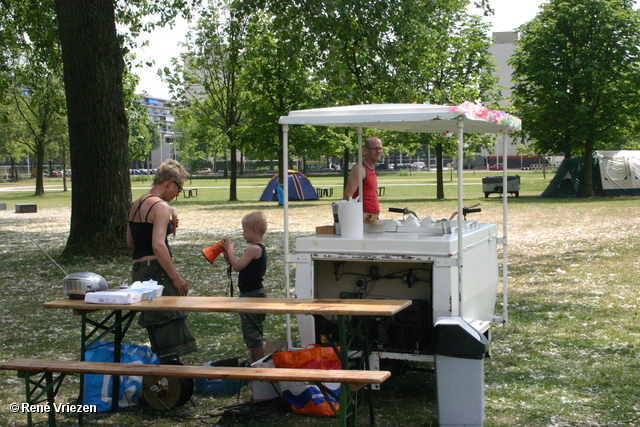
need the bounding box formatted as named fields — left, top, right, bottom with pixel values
left=136, top=0, right=546, bottom=99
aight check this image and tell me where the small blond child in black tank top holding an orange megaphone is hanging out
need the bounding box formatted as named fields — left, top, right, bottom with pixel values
left=202, top=211, right=267, bottom=363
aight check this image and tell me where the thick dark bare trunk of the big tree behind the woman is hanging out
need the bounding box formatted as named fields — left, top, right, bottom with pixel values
left=56, top=0, right=131, bottom=258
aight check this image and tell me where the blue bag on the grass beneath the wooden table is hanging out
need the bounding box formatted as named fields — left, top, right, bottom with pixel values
left=82, top=342, right=160, bottom=412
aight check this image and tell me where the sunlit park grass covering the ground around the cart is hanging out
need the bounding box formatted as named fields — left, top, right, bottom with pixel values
left=0, top=172, right=640, bottom=427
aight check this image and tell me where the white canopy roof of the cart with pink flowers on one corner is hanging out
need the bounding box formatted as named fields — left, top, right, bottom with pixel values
left=279, top=103, right=520, bottom=133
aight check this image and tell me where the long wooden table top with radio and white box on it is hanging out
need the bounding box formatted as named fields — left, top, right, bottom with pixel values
left=44, top=296, right=411, bottom=316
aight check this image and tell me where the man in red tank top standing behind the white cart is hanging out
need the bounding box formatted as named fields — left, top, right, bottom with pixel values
left=344, top=136, right=382, bottom=218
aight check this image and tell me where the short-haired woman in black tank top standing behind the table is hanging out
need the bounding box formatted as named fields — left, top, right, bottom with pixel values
left=127, top=160, right=198, bottom=361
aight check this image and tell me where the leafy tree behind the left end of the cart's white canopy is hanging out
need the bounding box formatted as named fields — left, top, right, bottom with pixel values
left=242, top=3, right=330, bottom=177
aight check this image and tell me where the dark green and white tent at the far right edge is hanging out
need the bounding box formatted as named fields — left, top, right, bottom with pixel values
left=540, top=150, right=640, bottom=197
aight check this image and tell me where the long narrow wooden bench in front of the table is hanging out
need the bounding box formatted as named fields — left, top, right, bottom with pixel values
left=0, top=359, right=391, bottom=426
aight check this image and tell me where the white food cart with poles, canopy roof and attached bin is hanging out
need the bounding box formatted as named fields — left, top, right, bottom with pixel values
left=279, top=102, right=520, bottom=426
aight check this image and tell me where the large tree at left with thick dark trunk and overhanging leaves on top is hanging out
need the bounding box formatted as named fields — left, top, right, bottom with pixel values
left=0, top=0, right=199, bottom=257
